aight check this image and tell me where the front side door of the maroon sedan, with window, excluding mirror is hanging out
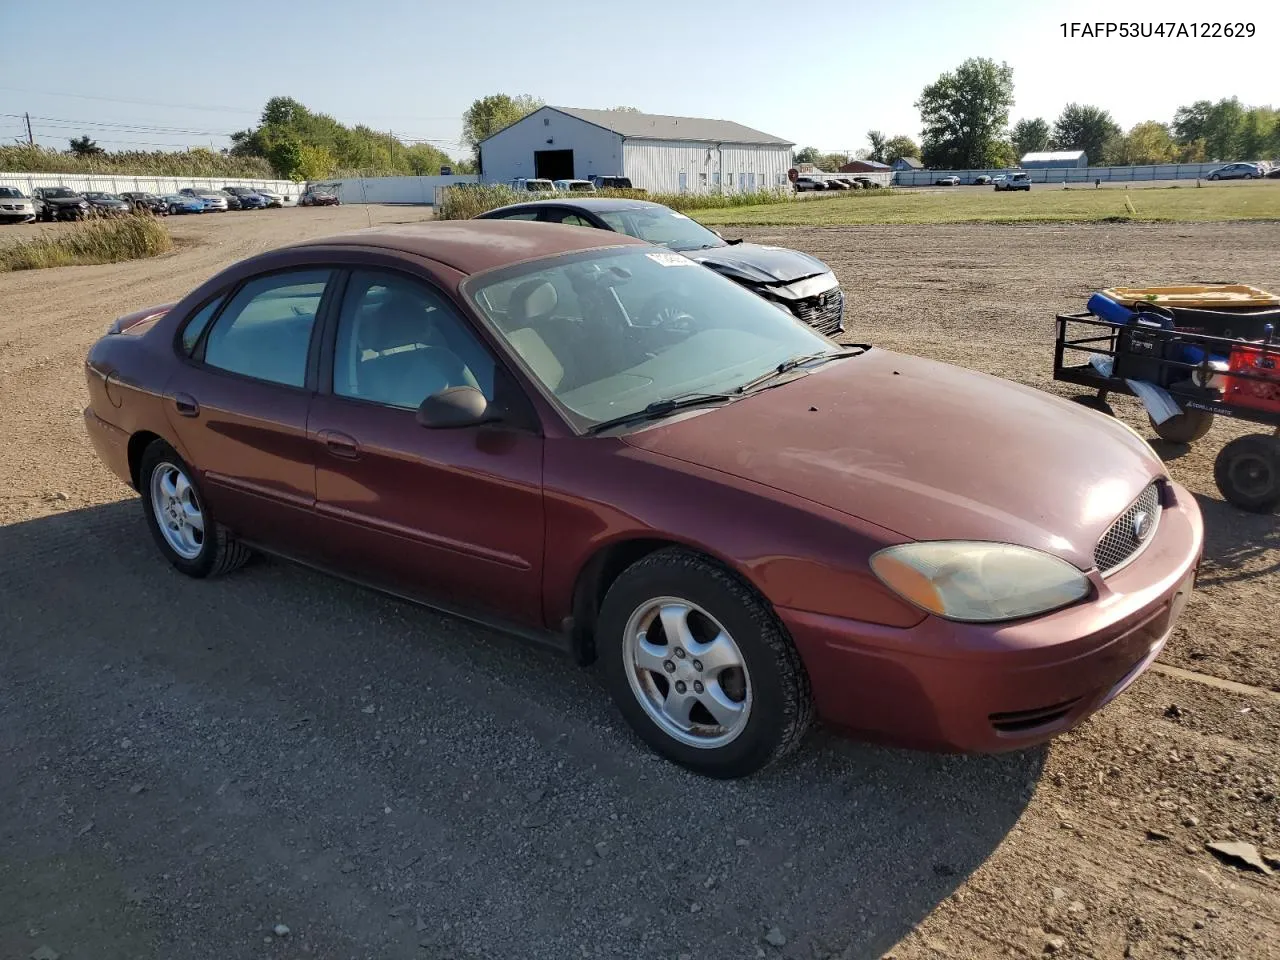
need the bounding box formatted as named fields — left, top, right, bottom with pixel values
left=307, top=266, right=543, bottom=626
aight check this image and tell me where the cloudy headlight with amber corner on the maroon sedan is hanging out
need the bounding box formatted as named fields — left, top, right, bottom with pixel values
left=870, top=540, right=1089, bottom=623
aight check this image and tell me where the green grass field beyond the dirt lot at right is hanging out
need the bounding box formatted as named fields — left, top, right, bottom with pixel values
left=690, top=182, right=1280, bottom=227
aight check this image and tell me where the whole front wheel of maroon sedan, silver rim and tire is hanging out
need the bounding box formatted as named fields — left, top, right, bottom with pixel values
left=595, top=548, right=813, bottom=778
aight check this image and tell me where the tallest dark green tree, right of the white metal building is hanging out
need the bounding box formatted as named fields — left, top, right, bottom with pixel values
left=915, top=58, right=1014, bottom=169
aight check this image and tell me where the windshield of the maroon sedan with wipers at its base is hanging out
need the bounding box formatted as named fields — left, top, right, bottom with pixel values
left=463, top=247, right=840, bottom=429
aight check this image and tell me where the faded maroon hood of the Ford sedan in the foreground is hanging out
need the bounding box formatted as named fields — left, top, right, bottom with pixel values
left=614, top=349, right=1165, bottom=570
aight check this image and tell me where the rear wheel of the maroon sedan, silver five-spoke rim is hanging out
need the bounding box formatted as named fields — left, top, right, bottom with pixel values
left=138, top=440, right=251, bottom=577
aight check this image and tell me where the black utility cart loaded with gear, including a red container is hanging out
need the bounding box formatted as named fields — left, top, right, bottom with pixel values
left=1053, top=308, right=1280, bottom=513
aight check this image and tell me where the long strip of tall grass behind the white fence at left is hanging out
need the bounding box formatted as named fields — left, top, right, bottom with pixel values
left=0, top=145, right=275, bottom=180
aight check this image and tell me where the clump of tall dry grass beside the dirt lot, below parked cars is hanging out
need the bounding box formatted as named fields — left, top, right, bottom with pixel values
left=0, top=214, right=173, bottom=271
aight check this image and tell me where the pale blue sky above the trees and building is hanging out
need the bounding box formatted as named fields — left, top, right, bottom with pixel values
left=0, top=0, right=1280, bottom=155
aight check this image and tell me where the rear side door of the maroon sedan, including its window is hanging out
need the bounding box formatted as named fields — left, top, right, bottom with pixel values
left=164, top=266, right=335, bottom=552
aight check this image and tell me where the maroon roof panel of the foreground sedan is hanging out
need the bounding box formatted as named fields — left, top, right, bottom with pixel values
left=292, top=220, right=657, bottom=274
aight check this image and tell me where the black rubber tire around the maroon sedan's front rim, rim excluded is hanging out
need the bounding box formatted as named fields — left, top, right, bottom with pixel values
left=595, top=548, right=813, bottom=780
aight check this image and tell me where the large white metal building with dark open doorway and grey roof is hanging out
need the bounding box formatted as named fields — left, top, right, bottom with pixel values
left=480, top=106, right=795, bottom=193
